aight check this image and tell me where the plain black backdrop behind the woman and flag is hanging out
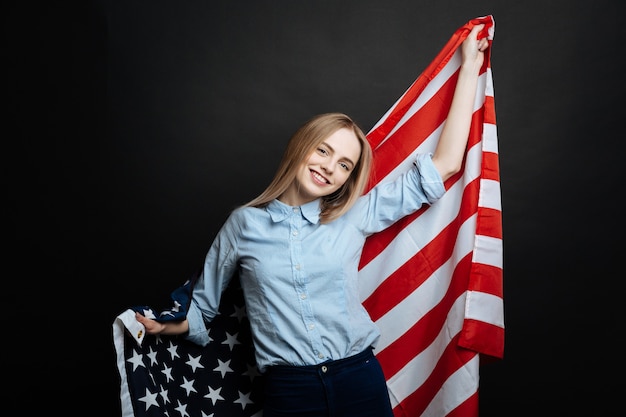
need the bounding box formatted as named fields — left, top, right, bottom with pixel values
left=3, top=0, right=626, bottom=417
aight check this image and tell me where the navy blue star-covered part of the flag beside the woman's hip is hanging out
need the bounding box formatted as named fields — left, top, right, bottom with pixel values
left=113, top=275, right=263, bottom=417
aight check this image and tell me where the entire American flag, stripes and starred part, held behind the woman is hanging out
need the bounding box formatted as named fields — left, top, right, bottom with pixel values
left=113, top=16, right=504, bottom=417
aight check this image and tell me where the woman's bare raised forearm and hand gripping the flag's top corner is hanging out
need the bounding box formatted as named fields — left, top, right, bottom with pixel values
left=433, top=24, right=489, bottom=181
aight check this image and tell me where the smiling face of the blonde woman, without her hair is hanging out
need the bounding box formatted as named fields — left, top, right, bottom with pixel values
left=281, top=128, right=361, bottom=206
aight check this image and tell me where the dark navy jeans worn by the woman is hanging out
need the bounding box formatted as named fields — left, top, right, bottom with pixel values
left=263, top=349, right=393, bottom=417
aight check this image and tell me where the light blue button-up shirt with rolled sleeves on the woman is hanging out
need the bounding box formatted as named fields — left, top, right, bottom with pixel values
left=186, top=154, right=445, bottom=372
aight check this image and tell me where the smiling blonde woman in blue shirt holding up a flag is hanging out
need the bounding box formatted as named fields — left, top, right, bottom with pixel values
left=136, top=25, right=488, bottom=417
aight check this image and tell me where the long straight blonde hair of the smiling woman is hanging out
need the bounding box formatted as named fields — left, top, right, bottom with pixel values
left=244, top=113, right=372, bottom=223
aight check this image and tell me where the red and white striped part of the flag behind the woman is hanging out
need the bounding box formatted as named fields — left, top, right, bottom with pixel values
left=359, top=16, right=504, bottom=417
